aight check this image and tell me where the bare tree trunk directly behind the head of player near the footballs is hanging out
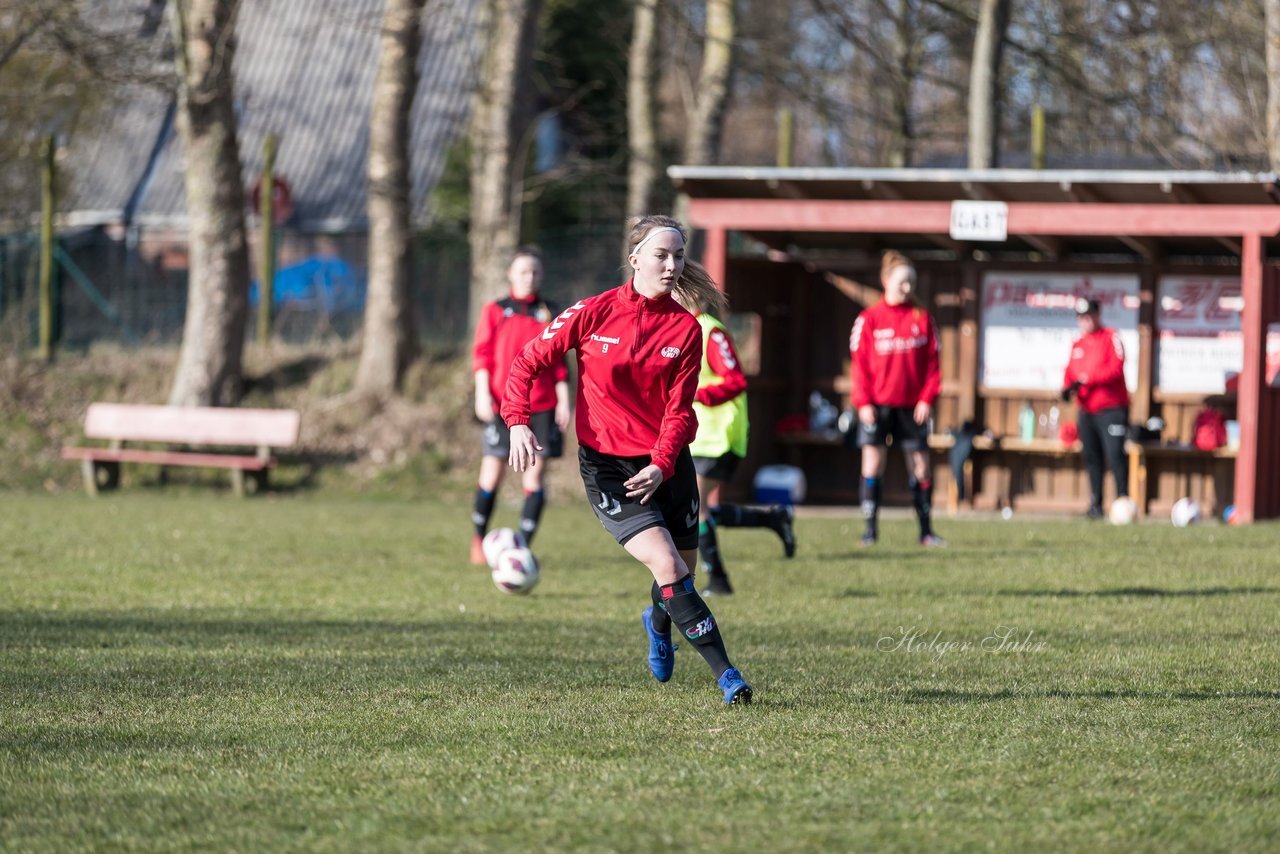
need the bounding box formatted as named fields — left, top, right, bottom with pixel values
left=468, top=0, right=541, bottom=326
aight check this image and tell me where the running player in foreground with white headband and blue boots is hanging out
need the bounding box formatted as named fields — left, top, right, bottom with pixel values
left=502, top=216, right=751, bottom=703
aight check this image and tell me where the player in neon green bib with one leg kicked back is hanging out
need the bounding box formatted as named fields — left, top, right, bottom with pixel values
left=676, top=293, right=796, bottom=595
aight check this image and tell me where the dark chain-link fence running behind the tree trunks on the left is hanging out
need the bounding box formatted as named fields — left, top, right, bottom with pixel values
left=0, top=224, right=623, bottom=350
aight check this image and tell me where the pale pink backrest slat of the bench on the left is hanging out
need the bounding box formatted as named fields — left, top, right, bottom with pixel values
left=84, top=403, right=302, bottom=450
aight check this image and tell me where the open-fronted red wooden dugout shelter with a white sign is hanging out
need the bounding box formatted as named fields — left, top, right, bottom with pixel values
left=669, top=166, right=1280, bottom=521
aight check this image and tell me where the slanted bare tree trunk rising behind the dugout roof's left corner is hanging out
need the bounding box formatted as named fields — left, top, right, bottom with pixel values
left=675, top=0, right=736, bottom=223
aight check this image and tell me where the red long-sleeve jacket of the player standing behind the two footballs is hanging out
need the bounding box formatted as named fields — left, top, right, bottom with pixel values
left=471, top=296, right=568, bottom=412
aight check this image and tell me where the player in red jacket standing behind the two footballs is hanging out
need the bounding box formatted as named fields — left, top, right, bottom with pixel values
left=471, top=246, right=570, bottom=563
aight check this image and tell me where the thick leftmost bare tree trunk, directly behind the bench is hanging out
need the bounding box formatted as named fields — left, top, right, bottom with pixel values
left=169, top=0, right=250, bottom=406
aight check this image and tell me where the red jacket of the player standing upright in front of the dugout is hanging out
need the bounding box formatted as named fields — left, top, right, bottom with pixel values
left=849, top=300, right=942, bottom=408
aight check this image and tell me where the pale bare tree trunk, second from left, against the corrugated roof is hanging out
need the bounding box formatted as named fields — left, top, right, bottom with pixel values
left=356, top=0, right=426, bottom=394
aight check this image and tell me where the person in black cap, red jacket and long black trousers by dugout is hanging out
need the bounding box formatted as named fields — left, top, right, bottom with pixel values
left=1062, top=298, right=1129, bottom=519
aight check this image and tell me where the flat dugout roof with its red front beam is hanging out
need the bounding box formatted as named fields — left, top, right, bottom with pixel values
left=668, top=166, right=1280, bottom=259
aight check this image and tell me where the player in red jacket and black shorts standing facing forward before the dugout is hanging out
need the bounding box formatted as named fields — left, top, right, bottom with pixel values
left=849, top=250, right=946, bottom=547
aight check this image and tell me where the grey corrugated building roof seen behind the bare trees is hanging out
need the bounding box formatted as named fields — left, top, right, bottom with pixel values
left=64, top=0, right=479, bottom=230
